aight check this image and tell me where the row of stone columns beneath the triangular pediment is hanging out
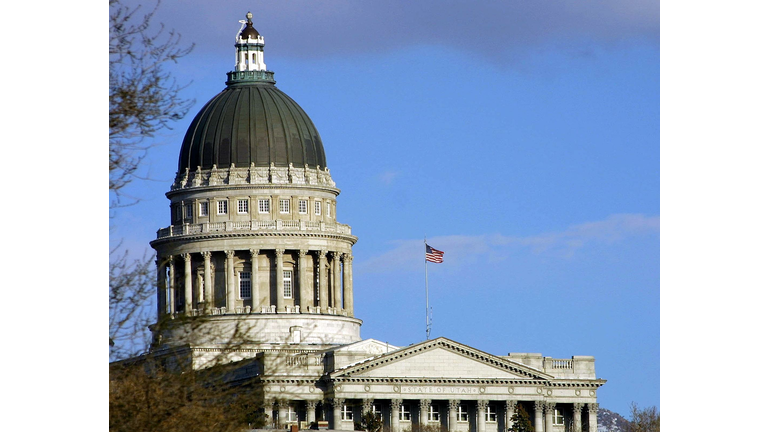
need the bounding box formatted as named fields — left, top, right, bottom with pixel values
left=265, top=398, right=598, bottom=432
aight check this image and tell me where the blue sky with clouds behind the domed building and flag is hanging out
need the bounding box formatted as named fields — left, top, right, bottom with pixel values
left=110, top=0, right=660, bottom=416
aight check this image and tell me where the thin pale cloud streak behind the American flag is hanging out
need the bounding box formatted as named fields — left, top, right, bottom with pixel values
left=355, top=214, right=660, bottom=272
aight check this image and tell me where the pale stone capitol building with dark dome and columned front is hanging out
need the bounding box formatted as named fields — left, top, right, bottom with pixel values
left=151, top=13, right=605, bottom=432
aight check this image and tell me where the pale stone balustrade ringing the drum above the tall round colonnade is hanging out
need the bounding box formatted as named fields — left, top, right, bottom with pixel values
left=157, top=220, right=352, bottom=239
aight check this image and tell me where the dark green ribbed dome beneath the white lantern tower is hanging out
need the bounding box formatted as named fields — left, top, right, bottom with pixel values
left=179, top=79, right=326, bottom=172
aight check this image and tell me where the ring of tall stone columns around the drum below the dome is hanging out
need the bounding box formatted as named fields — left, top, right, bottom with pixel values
left=155, top=249, right=354, bottom=317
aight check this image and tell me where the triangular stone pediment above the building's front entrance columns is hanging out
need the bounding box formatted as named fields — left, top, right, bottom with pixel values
left=330, top=337, right=554, bottom=380
